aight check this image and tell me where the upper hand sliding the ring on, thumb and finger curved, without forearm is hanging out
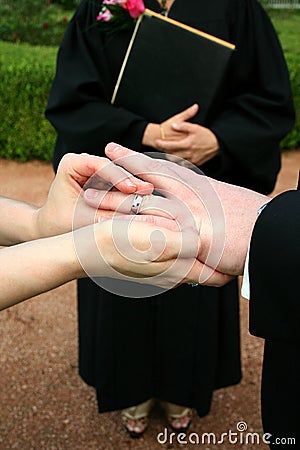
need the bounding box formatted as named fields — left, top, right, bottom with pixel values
left=33, top=153, right=153, bottom=238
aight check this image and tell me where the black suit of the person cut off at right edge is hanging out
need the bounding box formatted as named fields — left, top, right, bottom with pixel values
left=249, top=190, right=300, bottom=449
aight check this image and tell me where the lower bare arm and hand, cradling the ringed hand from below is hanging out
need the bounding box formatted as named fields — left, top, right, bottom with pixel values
left=0, top=220, right=201, bottom=310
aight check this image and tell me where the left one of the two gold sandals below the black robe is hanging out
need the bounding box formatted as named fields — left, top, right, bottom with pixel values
left=121, top=399, right=153, bottom=438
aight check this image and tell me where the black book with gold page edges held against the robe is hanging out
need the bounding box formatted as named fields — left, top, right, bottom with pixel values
left=111, top=10, right=235, bottom=124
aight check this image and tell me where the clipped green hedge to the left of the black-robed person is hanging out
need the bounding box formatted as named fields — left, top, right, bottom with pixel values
left=0, top=41, right=57, bottom=161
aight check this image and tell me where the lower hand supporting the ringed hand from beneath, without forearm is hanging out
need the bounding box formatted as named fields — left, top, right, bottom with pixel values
left=73, top=216, right=229, bottom=288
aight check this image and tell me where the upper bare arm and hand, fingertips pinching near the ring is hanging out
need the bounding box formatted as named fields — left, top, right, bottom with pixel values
left=0, top=153, right=153, bottom=246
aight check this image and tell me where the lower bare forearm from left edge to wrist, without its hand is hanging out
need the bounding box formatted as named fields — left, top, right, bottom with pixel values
left=0, top=233, right=84, bottom=309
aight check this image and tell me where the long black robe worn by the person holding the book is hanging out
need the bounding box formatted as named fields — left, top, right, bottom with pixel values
left=46, top=0, right=294, bottom=415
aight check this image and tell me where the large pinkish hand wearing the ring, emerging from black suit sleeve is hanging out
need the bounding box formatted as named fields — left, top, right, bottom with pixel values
left=85, top=144, right=270, bottom=286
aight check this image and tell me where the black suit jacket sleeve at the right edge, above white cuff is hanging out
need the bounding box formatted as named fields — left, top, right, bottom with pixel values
left=249, top=191, right=300, bottom=342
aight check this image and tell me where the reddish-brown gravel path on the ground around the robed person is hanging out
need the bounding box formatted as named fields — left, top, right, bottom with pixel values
left=0, top=151, right=300, bottom=450
